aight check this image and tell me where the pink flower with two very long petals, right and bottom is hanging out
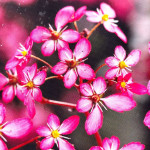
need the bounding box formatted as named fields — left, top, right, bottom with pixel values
left=76, top=77, right=136, bottom=135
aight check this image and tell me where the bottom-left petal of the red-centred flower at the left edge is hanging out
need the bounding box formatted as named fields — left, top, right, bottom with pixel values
left=2, top=85, right=15, bottom=103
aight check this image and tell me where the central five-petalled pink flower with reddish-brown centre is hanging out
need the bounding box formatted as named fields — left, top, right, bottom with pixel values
left=51, top=38, right=95, bottom=88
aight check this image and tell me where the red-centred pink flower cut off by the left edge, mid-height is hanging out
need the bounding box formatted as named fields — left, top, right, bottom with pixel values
left=0, top=68, right=22, bottom=103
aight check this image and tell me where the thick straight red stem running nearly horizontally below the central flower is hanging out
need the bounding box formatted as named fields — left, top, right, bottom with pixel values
left=42, top=97, right=76, bottom=109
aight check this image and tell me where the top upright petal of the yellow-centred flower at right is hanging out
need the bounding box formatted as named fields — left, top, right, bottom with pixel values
left=115, top=45, right=126, bottom=61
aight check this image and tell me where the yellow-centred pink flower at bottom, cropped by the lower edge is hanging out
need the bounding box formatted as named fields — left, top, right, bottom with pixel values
left=37, top=114, right=79, bottom=150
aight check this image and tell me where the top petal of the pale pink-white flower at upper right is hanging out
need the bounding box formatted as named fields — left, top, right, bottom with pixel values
left=100, top=2, right=116, bottom=18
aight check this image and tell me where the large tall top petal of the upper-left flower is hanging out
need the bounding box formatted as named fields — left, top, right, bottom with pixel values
left=55, top=6, right=75, bottom=31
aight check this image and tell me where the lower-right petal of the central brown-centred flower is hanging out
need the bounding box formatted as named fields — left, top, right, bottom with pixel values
left=77, top=63, right=95, bottom=80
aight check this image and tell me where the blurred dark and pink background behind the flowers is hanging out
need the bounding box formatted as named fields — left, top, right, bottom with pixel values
left=0, top=0, right=150, bottom=150
